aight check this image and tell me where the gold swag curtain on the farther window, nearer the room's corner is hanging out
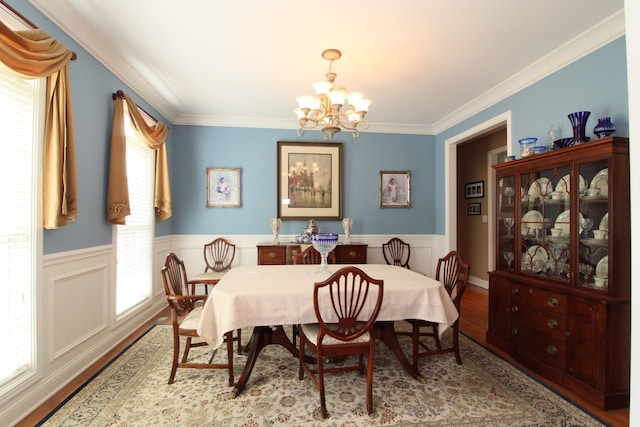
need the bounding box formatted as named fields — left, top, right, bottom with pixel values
left=107, top=91, right=171, bottom=225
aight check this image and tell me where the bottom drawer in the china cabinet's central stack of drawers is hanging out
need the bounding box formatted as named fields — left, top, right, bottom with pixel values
left=511, top=318, right=567, bottom=369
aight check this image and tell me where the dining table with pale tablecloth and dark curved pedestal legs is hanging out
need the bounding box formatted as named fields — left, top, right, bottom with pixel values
left=198, top=264, right=458, bottom=397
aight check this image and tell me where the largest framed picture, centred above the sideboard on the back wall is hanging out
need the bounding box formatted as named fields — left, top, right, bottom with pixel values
left=277, top=141, right=343, bottom=220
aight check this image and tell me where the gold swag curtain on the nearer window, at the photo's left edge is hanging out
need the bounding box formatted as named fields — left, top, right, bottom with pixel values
left=0, top=22, right=78, bottom=229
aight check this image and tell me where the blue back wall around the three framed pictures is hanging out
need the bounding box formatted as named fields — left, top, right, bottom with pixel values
left=171, top=126, right=435, bottom=234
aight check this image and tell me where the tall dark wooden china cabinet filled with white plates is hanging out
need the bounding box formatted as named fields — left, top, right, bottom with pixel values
left=487, top=137, right=631, bottom=409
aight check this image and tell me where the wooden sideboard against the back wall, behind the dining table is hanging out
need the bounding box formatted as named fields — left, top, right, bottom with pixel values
left=256, top=243, right=367, bottom=265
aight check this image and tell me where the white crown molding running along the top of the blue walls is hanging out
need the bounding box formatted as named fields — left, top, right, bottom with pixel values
left=29, top=0, right=625, bottom=135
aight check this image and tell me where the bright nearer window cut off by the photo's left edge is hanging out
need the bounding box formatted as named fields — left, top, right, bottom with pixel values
left=0, top=64, right=44, bottom=391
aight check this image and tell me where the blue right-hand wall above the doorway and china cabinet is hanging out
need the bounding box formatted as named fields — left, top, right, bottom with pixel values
left=436, top=37, right=629, bottom=234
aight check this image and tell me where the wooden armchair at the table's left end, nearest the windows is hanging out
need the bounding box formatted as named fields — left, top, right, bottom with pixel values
left=162, top=252, right=233, bottom=386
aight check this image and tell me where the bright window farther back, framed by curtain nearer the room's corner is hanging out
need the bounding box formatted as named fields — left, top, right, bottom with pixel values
left=115, top=105, right=155, bottom=315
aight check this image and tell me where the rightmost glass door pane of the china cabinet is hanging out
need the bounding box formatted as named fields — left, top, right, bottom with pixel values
left=577, top=160, right=609, bottom=290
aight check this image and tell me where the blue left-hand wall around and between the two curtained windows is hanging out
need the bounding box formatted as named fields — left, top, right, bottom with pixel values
left=11, top=0, right=174, bottom=254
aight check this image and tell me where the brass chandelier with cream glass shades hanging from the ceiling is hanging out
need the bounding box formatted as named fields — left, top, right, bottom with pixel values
left=294, top=49, right=371, bottom=140
